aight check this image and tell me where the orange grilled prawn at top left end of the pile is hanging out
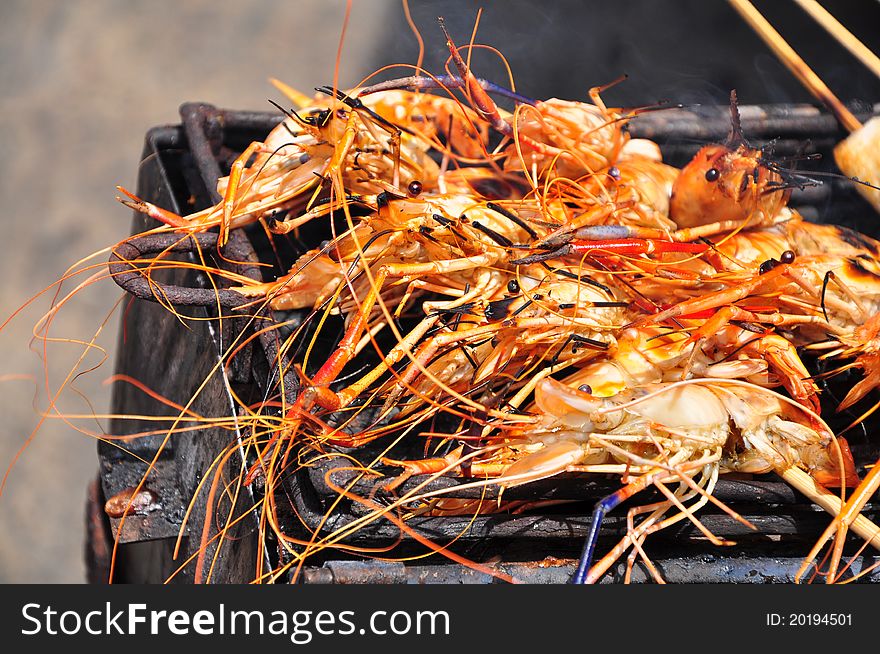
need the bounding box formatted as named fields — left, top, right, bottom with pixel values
left=120, top=88, right=439, bottom=244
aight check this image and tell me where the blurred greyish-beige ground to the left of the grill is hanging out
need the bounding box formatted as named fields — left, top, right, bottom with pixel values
left=0, top=0, right=399, bottom=582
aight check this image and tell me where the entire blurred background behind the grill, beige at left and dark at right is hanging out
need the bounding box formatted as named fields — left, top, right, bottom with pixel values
left=0, top=0, right=880, bottom=582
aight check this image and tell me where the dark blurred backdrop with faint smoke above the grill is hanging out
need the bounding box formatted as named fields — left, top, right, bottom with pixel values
left=375, top=0, right=880, bottom=111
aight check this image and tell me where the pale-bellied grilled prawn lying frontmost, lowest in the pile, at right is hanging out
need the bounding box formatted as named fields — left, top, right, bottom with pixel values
left=496, top=379, right=864, bottom=583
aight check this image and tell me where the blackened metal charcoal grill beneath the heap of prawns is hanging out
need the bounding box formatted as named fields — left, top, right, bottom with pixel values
left=90, top=98, right=880, bottom=583
